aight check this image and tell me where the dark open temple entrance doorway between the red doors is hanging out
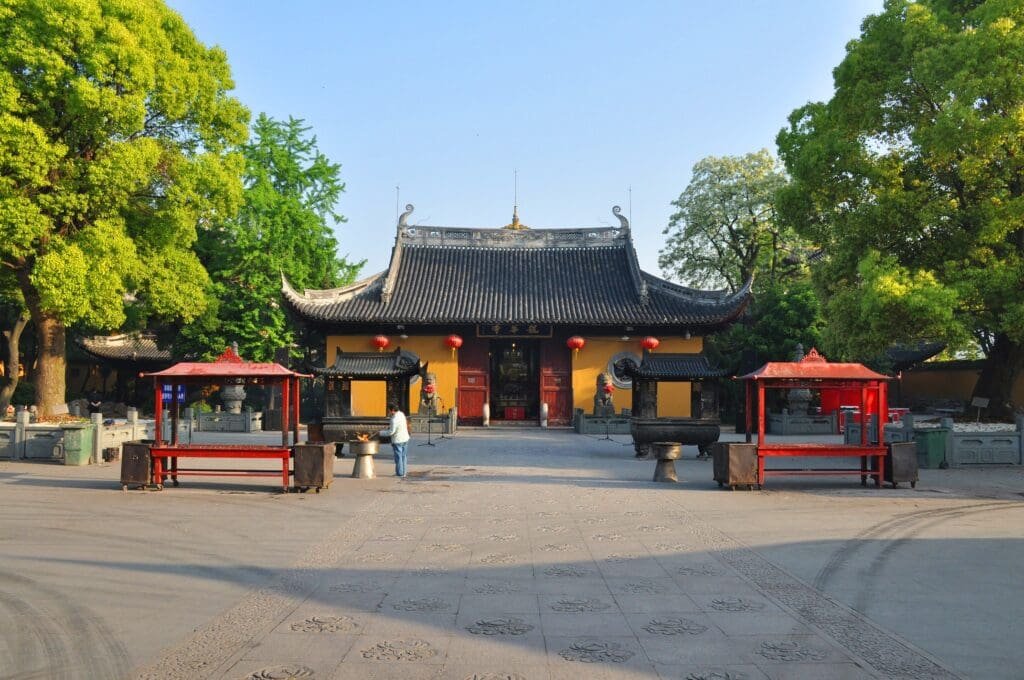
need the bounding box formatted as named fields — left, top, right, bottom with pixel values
left=490, top=339, right=541, bottom=423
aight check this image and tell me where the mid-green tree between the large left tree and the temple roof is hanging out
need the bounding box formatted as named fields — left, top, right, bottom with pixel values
left=176, top=115, right=362, bottom=362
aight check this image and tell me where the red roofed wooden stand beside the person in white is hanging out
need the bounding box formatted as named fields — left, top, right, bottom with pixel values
left=143, top=347, right=309, bottom=493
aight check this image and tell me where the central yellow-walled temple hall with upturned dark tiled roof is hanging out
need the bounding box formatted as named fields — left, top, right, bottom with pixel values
left=283, top=205, right=751, bottom=425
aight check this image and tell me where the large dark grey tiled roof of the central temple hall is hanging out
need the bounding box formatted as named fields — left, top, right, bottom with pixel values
left=283, top=213, right=750, bottom=330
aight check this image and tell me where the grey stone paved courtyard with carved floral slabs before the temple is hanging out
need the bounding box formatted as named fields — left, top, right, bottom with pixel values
left=0, top=429, right=1024, bottom=680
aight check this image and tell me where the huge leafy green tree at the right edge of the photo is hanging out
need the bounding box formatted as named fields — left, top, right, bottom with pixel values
left=777, top=0, right=1024, bottom=416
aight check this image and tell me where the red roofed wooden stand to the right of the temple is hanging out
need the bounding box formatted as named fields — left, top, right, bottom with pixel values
left=739, top=349, right=891, bottom=487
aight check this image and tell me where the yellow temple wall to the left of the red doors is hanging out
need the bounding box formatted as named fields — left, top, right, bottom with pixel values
left=327, top=335, right=459, bottom=416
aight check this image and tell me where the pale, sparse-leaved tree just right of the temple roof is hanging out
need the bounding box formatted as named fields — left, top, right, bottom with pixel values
left=658, top=150, right=803, bottom=291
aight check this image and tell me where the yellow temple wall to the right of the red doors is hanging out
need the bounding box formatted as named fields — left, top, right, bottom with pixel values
left=572, top=336, right=703, bottom=418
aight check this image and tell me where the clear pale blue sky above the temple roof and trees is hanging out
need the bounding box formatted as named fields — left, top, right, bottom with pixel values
left=169, top=0, right=882, bottom=274
